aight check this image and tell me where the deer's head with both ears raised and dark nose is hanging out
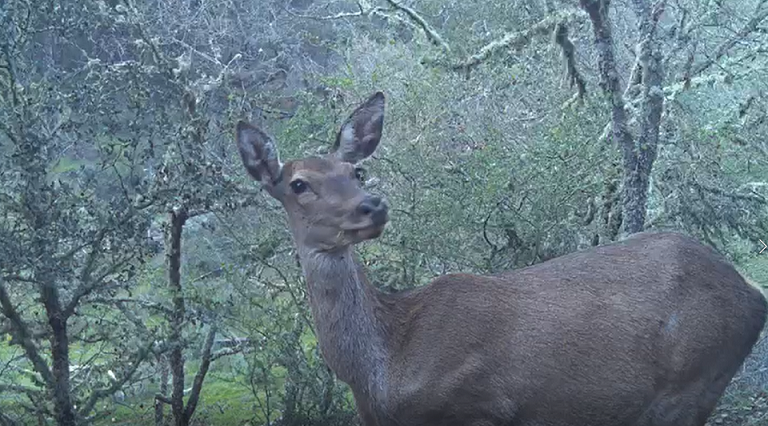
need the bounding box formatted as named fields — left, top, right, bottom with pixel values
left=236, top=92, right=389, bottom=251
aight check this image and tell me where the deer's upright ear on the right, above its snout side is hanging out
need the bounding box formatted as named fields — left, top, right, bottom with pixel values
left=333, top=92, right=384, bottom=164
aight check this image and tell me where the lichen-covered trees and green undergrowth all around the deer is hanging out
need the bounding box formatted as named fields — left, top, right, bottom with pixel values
left=0, top=0, right=768, bottom=426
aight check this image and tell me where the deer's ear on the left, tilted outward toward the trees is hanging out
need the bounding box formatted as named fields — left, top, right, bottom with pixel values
left=235, top=121, right=283, bottom=196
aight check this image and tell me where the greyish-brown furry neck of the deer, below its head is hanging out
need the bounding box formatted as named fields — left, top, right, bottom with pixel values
left=299, top=247, right=388, bottom=400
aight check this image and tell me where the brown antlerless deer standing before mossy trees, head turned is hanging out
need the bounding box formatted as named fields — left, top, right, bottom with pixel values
left=235, top=91, right=768, bottom=426
